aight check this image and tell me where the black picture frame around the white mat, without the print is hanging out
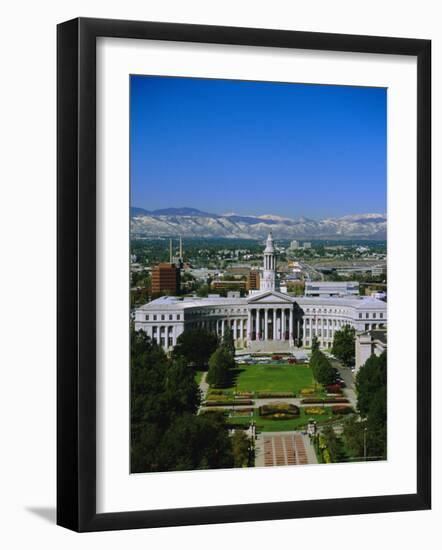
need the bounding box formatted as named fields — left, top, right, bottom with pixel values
left=57, top=18, right=431, bottom=532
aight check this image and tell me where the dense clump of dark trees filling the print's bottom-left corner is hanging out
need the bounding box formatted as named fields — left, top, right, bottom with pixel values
left=131, top=326, right=233, bottom=472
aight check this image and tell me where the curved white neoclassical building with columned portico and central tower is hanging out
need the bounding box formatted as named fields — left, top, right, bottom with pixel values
left=135, top=235, right=387, bottom=353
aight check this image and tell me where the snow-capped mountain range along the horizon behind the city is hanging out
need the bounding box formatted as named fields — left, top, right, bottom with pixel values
left=131, top=207, right=387, bottom=240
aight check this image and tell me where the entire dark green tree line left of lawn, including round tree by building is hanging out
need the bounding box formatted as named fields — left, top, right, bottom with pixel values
left=131, top=327, right=249, bottom=473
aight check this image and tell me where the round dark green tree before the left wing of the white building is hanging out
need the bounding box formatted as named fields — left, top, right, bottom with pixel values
left=173, top=329, right=218, bottom=367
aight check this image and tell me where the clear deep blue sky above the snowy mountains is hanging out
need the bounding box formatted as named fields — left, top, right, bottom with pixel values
left=130, top=76, right=387, bottom=219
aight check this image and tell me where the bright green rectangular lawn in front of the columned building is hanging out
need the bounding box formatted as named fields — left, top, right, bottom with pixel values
left=231, top=363, right=315, bottom=394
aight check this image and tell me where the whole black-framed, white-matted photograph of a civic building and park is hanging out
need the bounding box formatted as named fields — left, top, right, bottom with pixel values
left=57, top=18, right=431, bottom=531
